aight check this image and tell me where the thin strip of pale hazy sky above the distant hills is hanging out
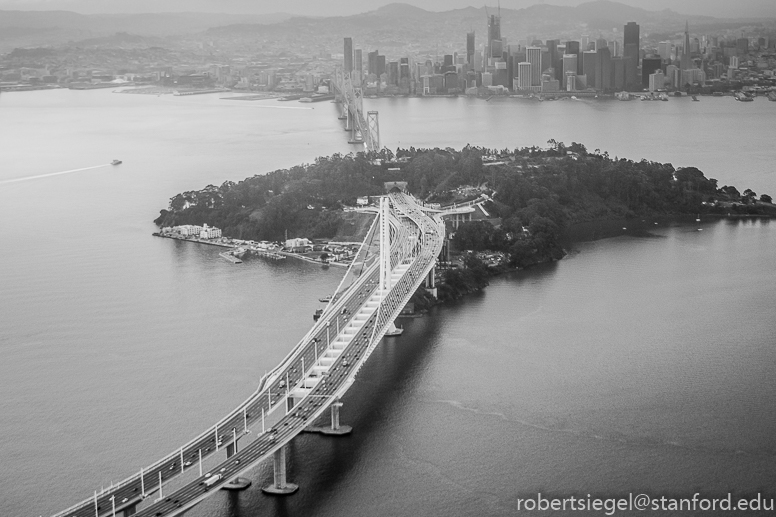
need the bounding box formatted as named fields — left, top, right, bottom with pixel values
left=0, top=0, right=776, bottom=17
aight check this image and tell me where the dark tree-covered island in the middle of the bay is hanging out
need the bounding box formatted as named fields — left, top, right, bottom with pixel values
left=154, top=140, right=776, bottom=305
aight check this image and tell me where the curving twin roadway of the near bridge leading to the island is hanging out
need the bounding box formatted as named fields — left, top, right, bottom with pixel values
left=54, top=193, right=444, bottom=517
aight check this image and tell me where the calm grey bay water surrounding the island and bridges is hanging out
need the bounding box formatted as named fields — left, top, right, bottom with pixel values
left=0, top=90, right=776, bottom=517
